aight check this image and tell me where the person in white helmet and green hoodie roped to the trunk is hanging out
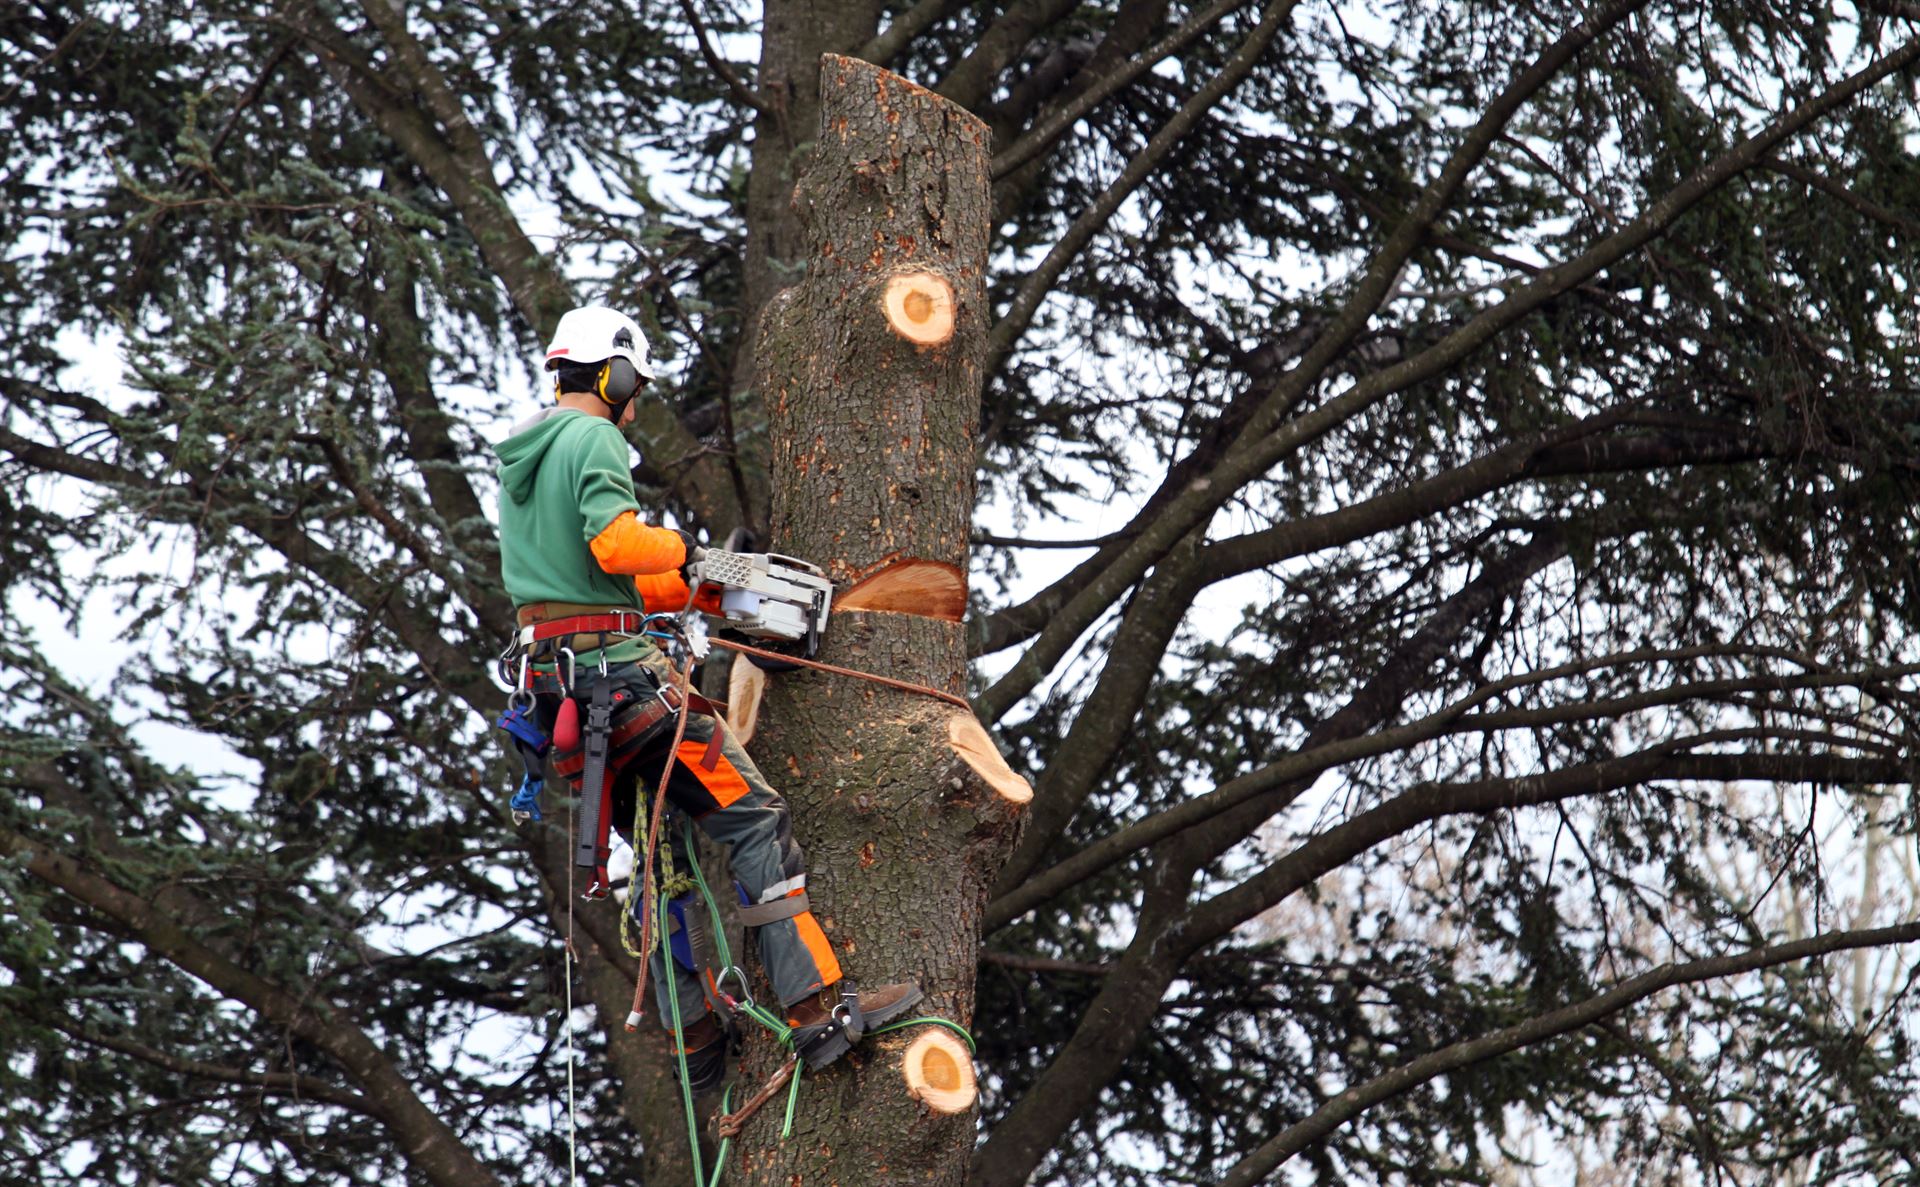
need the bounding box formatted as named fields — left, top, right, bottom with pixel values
left=495, top=305, right=920, bottom=1093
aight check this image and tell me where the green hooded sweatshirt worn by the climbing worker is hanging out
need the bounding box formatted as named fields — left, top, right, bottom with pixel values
left=493, top=407, right=639, bottom=609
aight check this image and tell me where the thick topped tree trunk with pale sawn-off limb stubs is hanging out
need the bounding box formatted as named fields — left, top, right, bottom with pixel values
left=739, top=56, right=1018, bottom=1187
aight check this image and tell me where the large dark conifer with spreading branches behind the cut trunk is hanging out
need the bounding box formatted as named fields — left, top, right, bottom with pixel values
left=0, top=0, right=1920, bottom=1185
